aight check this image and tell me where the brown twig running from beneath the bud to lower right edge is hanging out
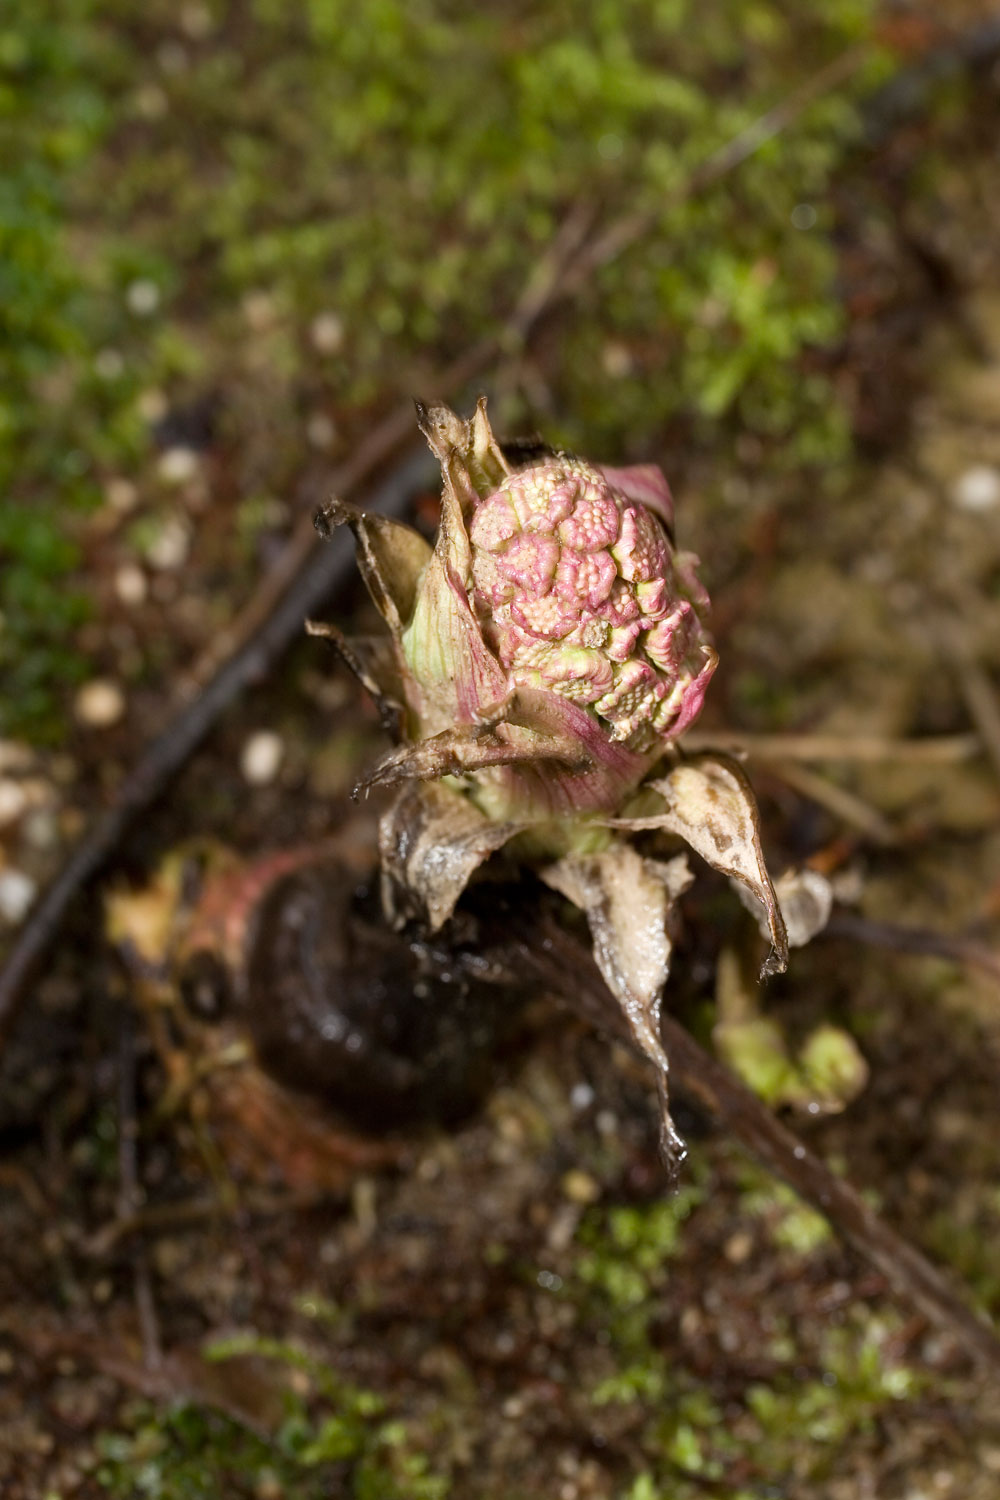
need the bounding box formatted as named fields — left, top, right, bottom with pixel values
left=517, top=915, right=1000, bottom=1376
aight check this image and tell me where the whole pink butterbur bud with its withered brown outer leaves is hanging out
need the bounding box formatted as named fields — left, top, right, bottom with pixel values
left=310, top=401, right=786, bottom=1158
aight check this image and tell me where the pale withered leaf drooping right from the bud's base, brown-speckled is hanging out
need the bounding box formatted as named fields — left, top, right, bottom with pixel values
left=612, top=755, right=789, bottom=978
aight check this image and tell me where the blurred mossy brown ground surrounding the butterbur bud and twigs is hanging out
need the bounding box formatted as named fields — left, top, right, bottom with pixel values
left=0, top=0, right=1000, bottom=1500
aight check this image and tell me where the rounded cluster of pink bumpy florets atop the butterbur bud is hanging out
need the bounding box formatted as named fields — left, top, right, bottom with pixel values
left=468, top=458, right=717, bottom=750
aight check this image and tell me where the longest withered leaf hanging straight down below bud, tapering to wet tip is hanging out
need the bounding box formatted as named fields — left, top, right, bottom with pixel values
left=540, top=843, right=691, bottom=1169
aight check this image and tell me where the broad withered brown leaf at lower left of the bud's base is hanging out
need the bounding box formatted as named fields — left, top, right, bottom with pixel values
left=378, top=782, right=522, bottom=932
